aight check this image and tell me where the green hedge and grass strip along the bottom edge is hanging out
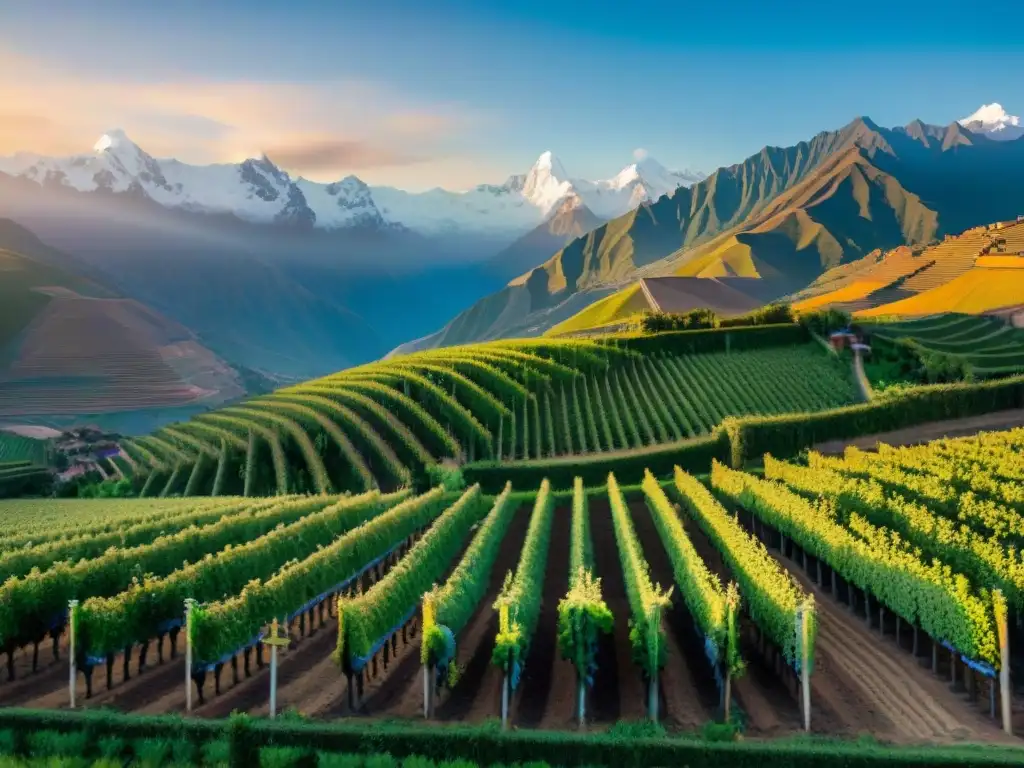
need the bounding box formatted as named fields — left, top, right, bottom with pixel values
left=0, top=709, right=1024, bottom=768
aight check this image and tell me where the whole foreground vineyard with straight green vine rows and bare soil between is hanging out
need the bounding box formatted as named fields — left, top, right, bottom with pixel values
left=0, top=429, right=1024, bottom=743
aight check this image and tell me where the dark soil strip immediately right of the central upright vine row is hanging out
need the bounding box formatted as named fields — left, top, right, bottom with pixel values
left=588, top=497, right=647, bottom=725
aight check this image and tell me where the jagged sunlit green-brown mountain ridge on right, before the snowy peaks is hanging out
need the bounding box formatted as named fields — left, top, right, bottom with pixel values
left=400, top=118, right=1024, bottom=350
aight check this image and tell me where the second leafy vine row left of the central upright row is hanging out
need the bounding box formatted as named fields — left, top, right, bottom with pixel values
left=421, top=482, right=517, bottom=664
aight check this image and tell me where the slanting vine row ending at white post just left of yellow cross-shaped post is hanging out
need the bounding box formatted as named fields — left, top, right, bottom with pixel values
left=193, top=487, right=445, bottom=664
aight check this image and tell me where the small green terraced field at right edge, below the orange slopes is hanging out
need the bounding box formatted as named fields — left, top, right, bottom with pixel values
left=867, top=314, right=1024, bottom=378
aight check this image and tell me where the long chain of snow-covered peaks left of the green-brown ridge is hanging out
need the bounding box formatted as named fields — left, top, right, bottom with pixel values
left=0, top=130, right=703, bottom=234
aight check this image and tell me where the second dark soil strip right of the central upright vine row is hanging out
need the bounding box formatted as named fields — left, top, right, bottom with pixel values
left=627, top=498, right=720, bottom=730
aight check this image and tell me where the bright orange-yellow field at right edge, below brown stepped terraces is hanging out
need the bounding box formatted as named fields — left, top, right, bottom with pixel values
left=854, top=267, right=1024, bottom=317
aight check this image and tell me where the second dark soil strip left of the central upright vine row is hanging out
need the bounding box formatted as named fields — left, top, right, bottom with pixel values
left=430, top=506, right=532, bottom=723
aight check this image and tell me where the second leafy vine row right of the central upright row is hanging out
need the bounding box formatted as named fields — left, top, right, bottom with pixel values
left=641, top=470, right=738, bottom=664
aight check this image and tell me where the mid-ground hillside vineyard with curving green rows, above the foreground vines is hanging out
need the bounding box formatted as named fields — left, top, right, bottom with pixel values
left=114, top=326, right=856, bottom=497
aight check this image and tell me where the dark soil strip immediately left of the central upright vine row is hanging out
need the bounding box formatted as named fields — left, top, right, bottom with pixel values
left=511, top=507, right=577, bottom=729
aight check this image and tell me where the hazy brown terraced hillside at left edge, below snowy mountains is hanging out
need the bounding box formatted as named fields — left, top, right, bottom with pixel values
left=0, top=221, right=246, bottom=434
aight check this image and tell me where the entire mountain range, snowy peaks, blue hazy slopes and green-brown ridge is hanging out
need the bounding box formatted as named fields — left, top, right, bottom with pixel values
left=0, top=104, right=1024, bottom=434
